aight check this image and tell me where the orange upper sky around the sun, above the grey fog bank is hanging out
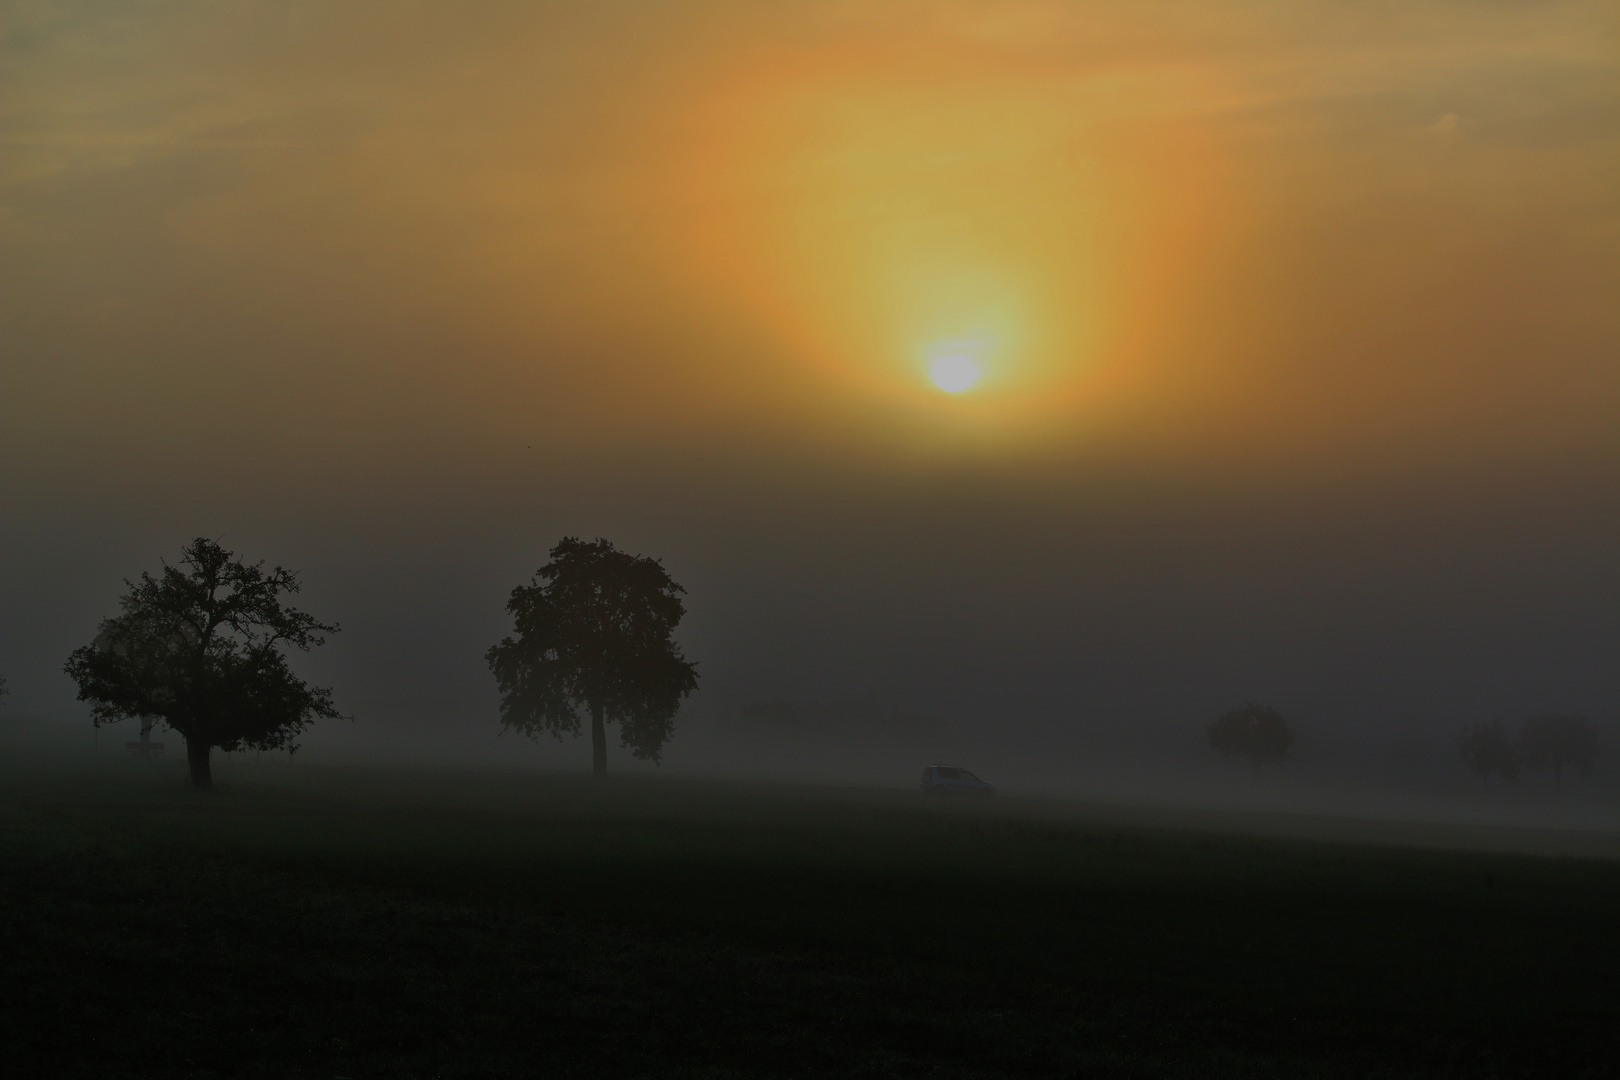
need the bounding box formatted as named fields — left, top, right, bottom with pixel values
left=0, top=2, right=1620, bottom=495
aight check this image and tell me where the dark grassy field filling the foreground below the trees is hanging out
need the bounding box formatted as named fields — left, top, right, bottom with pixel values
left=0, top=763, right=1620, bottom=1080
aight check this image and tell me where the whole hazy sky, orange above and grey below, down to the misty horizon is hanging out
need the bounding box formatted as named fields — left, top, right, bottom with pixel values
left=0, top=0, right=1620, bottom=767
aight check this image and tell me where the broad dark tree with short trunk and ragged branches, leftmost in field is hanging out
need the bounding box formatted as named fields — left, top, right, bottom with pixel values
left=66, top=538, right=340, bottom=789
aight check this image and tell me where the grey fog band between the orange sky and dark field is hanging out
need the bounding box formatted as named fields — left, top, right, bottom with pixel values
left=3, top=453, right=1620, bottom=826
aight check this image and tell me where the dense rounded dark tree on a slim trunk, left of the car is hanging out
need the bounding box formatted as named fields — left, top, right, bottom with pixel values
left=488, top=536, right=698, bottom=776
